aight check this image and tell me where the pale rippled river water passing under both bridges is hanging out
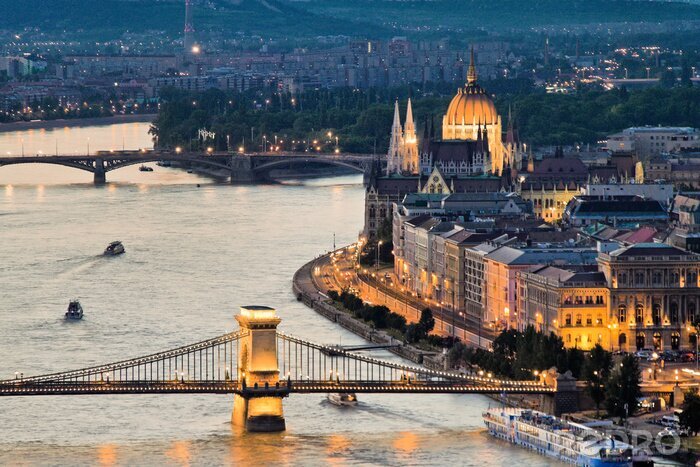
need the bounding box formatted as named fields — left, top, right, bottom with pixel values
left=0, top=124, right=550, bottom=466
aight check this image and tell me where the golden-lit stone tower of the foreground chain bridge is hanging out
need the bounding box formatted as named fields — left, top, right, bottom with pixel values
left=231, top=306, right=289, bottom=432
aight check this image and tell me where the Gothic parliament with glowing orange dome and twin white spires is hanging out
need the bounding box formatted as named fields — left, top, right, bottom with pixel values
left=363, top=48, right=525, bottom=239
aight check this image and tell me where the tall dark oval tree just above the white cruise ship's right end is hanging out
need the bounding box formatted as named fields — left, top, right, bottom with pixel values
left=605, top=355, right=642, bottom=419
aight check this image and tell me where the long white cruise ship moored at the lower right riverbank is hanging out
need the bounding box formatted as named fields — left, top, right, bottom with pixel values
left=483, top=407, right=648, bottom=467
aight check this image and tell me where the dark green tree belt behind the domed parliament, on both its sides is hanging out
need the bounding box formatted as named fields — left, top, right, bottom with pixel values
left=152, top=80, right=700, bottom=153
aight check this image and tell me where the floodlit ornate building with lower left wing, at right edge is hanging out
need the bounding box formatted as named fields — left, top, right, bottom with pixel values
left=517, top=243, right=700, bottom=352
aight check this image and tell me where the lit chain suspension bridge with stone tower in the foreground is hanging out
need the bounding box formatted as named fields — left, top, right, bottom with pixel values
left=0, top=306, right=556, bottom=431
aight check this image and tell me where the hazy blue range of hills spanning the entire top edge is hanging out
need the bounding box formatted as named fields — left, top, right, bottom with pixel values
left=0, top=0, right=700, bottom=38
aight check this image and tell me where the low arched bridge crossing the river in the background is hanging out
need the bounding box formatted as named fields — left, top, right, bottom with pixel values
left=0, top=150, right=377, bottom=184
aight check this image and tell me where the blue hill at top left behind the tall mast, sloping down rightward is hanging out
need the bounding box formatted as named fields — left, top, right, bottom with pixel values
left=0, top=0, right=376, bottom=37
